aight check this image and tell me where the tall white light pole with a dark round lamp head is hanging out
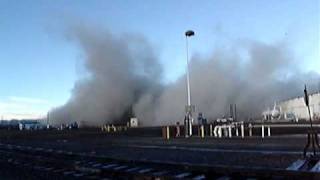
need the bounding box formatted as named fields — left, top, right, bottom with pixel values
left=184, top=30, right=194, bottom=137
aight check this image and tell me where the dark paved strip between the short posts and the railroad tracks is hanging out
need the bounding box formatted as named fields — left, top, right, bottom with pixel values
left=0, top=130, right=312, bottom=168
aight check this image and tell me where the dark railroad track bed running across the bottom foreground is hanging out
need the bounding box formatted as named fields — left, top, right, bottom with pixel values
left=0, top=143, right=320, bottom=180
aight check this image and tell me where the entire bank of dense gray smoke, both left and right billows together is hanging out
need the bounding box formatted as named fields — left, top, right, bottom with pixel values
left=51, top=27, right=320, bottom=126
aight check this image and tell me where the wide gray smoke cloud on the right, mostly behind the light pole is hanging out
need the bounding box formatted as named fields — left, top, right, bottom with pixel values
left=155, top=42, right=320, bottom=124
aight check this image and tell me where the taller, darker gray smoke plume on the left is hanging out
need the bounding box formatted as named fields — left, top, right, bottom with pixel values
left=51, top=26, right=162, bottom=125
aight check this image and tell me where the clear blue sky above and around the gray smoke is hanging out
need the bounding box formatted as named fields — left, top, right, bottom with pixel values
left=0, top=0, right=320, bottom=119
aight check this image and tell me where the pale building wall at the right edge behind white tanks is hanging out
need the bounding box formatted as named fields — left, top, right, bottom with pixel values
left=278, top=92, right=320, bottom=119
